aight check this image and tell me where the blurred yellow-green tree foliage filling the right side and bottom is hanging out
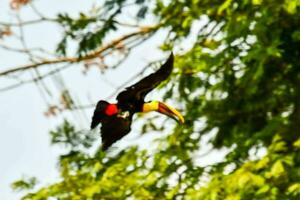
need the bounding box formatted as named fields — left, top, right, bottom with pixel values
left=15, top=0, right=300, bottom=200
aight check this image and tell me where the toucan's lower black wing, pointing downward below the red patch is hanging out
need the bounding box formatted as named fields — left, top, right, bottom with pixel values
left=100, top=116, right=131, bottom=151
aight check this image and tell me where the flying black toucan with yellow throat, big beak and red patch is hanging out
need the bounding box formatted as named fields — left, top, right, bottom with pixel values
left=91, top=53, right=184, bottom=151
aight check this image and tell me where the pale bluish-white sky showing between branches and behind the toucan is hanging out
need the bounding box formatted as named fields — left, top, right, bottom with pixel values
left=0, top=0, right=227, bottom=200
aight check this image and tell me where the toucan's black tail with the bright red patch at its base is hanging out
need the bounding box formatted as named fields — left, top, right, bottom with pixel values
left=91, top=100, right=118, bottom=129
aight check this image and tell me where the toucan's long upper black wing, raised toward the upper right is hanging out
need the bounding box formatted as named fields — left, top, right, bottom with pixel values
left=117, top=53, right=174, bottom=104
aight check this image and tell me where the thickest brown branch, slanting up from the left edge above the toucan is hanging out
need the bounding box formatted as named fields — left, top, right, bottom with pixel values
left=0, top=27, right=157, bottom=76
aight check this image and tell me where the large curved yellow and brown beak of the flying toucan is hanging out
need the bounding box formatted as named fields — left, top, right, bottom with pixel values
left=143, top=101, right=184, bottom=124
